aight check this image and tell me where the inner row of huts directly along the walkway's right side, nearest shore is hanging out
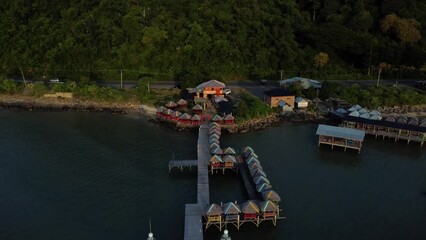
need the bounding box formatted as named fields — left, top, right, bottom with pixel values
left=209, top=122, right=237, bottom=174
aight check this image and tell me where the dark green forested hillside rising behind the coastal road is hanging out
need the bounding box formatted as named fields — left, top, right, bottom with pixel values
left=0, top=0, right=426, bottom=81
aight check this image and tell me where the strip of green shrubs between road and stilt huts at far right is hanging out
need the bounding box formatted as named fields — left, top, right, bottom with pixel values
left=320, top=82, right=426, bottom=108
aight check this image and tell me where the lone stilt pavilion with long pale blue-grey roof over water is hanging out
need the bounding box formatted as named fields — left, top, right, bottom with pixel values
left=316, top=124, right=365, bottom=152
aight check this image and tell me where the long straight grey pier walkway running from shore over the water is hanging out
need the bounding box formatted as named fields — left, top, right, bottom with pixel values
left=183, top=124, right=210, bottom=240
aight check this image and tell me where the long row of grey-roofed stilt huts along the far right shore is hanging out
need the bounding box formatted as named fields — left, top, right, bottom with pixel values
left=336, top=105, right=426, bottom=146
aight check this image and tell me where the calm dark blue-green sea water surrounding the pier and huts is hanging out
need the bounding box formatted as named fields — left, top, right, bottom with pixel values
left=0, top=111, right=426, bottom=240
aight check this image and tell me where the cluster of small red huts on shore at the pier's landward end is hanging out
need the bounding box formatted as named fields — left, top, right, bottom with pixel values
left=156, top=99, right=235, bottom=126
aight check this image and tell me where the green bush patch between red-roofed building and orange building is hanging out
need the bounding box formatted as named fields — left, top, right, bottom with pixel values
left=235, top=91, right=274, bottom=122
